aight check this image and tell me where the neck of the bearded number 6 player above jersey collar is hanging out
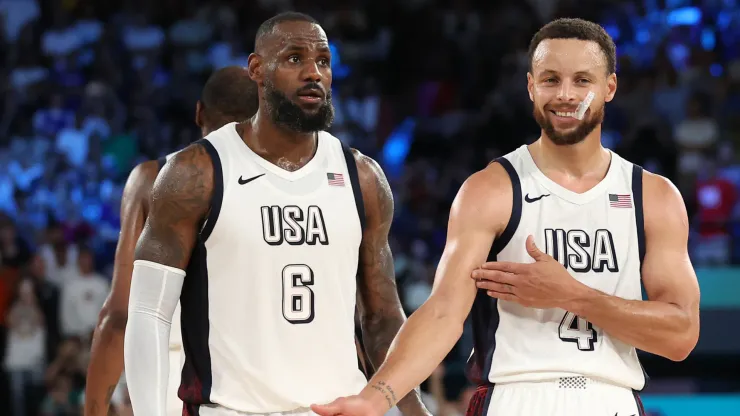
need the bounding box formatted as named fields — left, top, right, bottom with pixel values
left=239, top=112, right=318, bottom=170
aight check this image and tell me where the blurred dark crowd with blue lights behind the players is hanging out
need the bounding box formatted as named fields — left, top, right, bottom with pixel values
left=0, top=0, right=740, bottom=416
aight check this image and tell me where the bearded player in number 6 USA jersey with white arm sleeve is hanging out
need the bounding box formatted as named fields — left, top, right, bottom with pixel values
left=124, top=13, right=428, bottom=416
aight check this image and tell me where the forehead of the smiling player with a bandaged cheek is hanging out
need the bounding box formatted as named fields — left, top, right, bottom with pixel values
left=532, top=39, right=606, bottom=73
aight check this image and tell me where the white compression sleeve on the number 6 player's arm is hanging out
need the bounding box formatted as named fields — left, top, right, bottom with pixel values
left=123, top=260, right=185, bottom=416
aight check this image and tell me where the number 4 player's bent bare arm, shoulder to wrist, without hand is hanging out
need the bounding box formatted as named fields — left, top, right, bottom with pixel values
left=564, top=173, right=699, bottom=361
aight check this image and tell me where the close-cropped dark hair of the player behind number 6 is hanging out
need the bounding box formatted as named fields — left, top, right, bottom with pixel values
left=200, top=66, right=259, bottom=122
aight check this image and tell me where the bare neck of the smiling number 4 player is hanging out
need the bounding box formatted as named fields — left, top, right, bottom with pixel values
left=529, top=128, right=611, bottom=179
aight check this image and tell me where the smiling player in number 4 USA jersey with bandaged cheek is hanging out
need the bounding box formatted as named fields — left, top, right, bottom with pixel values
left=313, top=19, right=699, bottom=416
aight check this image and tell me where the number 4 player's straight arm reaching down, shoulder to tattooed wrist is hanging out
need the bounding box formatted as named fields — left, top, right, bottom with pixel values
left=360, top=163, right=512, bottom=414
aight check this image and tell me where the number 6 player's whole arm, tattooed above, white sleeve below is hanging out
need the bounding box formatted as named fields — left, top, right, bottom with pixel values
left=124, top=144, right=214, bottom=416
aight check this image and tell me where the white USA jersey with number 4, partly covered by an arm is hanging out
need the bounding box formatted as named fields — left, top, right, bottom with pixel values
left=468, top=146, right=646, bottom=390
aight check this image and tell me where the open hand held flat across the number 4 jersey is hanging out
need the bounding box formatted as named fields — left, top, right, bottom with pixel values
left=472, top=235, right=585, bottom=309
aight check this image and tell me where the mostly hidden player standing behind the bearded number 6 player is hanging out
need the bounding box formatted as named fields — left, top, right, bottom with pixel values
left=85, top=66, right=257, bottom=416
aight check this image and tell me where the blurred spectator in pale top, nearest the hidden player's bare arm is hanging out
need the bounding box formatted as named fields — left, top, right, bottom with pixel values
left=60, top=248, right=110, bottom=340
